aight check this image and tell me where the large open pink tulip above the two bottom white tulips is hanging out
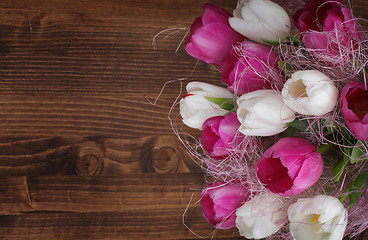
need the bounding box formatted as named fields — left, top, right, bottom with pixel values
left=256, top=137, right=323, bottom=197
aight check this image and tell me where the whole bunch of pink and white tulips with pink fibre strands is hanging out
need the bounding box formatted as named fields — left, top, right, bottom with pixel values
left=176, top=0, right=368, bottom=240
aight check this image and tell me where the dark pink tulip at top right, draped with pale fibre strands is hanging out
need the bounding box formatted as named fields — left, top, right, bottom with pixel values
left=293, top=0, right=360, bottom=60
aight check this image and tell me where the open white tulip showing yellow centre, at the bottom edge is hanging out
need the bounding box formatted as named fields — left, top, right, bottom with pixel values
left=288, top=195, right=347, bottom=240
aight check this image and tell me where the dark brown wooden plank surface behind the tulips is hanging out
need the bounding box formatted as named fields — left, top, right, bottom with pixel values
left=0, top=0, right=368, bottom=239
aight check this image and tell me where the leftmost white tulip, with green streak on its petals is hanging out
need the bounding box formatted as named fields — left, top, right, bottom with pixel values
left=180, top=82, right=233, bottom=130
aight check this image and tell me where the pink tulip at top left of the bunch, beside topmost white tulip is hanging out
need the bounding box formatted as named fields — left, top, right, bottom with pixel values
left=185, top=3, right=244, bottom=66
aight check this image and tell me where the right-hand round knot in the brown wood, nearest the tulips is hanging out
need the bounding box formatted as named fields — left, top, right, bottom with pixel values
left=152, top=147, right=180, bottom=173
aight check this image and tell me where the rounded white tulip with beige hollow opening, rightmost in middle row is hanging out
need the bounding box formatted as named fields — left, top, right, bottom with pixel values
left=281, top=70, right=339, bottom=116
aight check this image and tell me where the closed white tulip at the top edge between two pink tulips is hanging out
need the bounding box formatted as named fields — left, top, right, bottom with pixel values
left=229, top=0, right=291, bottom=44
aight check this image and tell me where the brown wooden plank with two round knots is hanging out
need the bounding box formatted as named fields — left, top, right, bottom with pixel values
left=0, top=136, right=202, bottom=177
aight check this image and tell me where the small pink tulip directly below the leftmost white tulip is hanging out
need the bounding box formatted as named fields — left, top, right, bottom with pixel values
left=201, top=112, right=243, bottom=159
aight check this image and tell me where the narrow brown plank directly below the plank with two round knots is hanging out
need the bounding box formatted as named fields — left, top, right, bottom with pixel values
left=0, top=173, right=204, bottom=215
